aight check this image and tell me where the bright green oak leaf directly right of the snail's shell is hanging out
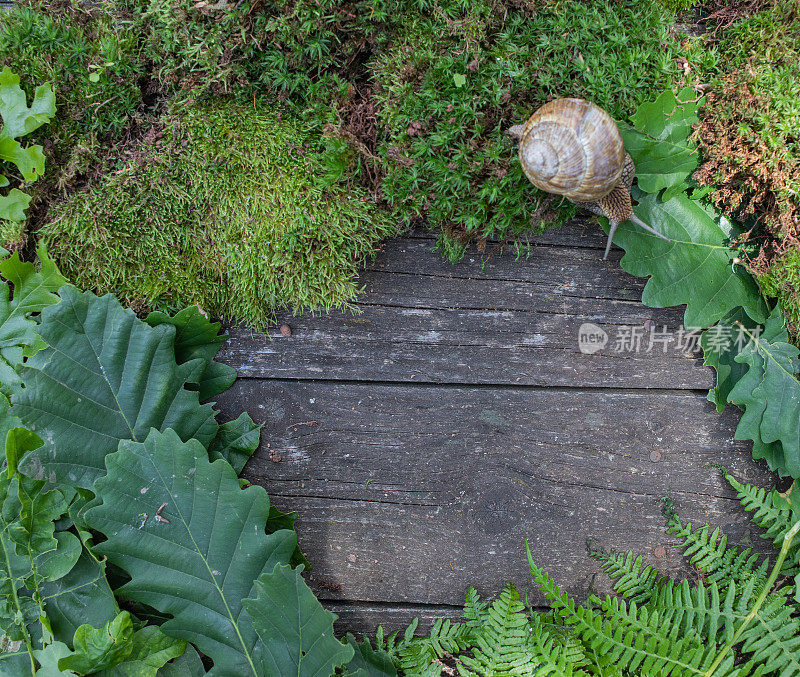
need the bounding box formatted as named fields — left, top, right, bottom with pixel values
left=618, top=88, right=702, bottom=194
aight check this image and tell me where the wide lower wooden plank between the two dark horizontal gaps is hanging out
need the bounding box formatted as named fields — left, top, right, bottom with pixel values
left=220, top=379, right=768, bottom=605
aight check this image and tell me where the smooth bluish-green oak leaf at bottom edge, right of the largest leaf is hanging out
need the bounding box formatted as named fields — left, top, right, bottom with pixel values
left=243, top=564, right=354, bottom=677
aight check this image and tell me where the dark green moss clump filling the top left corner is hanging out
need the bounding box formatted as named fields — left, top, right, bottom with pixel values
left=0, top=0, right=143, bottom=188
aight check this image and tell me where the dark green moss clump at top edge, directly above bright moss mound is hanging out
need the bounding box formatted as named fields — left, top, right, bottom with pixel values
left=115, top=0, right=386, bottom=113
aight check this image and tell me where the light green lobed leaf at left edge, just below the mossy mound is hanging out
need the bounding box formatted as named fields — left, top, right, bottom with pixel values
left=0, top=246, right=66, bottom=395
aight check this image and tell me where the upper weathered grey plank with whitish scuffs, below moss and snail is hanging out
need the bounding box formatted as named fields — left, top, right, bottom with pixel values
left=221, top=229, right=713, bottom=389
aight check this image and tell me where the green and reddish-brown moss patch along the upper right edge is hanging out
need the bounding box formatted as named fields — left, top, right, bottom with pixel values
left=695, top=0, right=800, bottom=333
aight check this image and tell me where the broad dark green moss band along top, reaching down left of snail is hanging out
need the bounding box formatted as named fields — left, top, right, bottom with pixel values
left=108, top=0, right=700, bottom=259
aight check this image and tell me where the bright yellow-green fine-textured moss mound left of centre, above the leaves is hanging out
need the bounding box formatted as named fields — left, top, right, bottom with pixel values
left=39, top=101, right=393, bottom=327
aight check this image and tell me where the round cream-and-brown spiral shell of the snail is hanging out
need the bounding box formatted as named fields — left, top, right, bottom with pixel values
left=519, top=99, right=625, bottom=202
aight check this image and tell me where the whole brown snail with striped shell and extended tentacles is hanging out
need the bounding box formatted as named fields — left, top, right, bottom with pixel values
left=508, top=99, right=669, bottom=259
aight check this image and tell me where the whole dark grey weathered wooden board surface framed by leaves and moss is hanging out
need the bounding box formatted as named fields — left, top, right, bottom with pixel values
left=214, top=224, right=771, bottom=631
